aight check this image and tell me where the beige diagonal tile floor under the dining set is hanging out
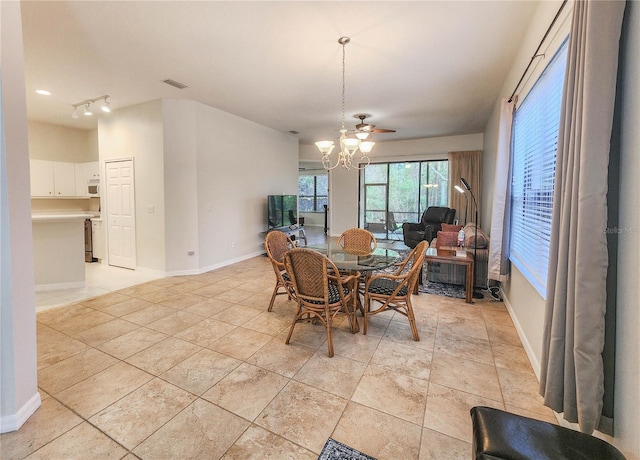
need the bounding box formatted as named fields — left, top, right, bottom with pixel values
left=0, top=228, right=554, bottom=460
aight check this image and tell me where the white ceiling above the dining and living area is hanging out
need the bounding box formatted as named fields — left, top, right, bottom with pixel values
left=22, top=1, right=537, bottom=144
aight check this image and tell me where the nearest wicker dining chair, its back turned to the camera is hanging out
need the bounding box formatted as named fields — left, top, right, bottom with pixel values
left=284, top=248, right=358, bottom=358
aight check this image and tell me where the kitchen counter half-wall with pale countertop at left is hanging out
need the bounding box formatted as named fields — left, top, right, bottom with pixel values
left=31, top=211, right=95, bottom=291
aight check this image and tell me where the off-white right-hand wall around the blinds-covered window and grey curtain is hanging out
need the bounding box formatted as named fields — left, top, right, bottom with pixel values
left=483, top=1, right=640, bottom=459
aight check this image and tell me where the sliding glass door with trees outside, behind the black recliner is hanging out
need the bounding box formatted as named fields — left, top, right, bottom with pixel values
left=359, top=160, right=449, bottom=240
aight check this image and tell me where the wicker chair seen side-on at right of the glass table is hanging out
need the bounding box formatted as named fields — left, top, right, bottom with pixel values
left=363, top=241, right=429, bottom=341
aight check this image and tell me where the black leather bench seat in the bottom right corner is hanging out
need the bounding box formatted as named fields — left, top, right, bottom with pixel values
left=471, top=406, right=625, bottom=460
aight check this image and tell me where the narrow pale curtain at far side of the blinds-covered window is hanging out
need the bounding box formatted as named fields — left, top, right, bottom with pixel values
left=488, top=98, right=517, bottom=281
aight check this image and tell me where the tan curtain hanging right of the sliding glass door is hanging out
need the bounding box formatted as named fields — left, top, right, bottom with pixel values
left=449, top=150, right=482, bottom=227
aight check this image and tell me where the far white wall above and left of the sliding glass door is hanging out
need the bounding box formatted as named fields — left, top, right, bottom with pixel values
left=300, top=134, right=483, bottom=236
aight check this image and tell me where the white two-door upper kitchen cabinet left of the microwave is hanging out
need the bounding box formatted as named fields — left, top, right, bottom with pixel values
left=30, top=160, right=76, bottom=197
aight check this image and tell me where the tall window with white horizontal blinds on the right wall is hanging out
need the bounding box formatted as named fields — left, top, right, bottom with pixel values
left=510, top=40, right=567, bottom=297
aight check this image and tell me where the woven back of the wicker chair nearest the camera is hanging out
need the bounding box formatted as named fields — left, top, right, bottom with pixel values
left=284, top=248, right=338, bottom=302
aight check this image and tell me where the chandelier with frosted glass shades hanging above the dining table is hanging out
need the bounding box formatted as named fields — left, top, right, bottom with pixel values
left=316, top=37, right=375, bottom=171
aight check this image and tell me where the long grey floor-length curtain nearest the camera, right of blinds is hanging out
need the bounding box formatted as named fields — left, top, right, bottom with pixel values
left=540, top=0, right=625, bottom=433
